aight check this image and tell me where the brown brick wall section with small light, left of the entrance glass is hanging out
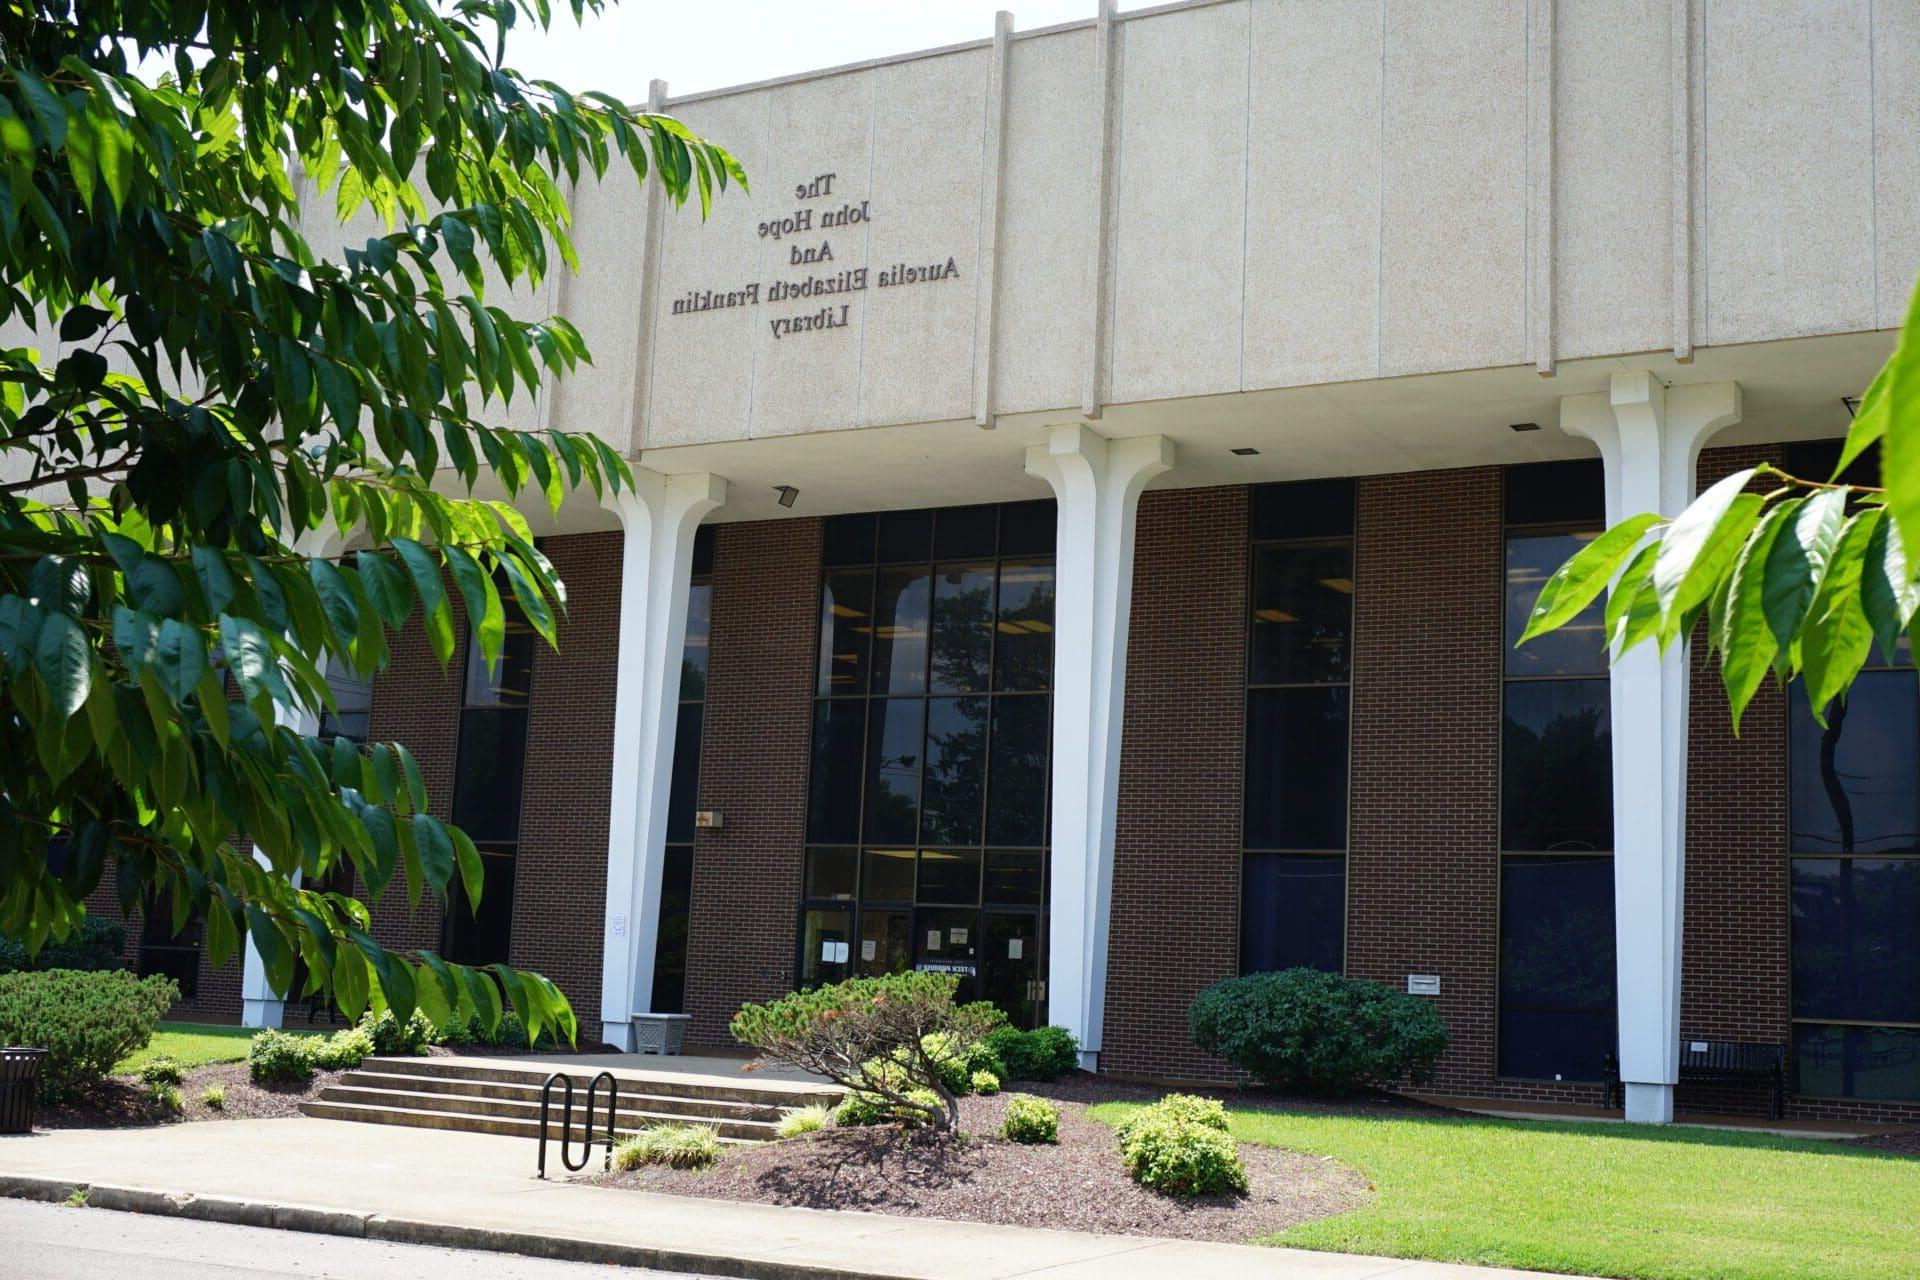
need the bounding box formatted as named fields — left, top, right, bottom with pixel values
left=687, top=520, right=820, bottom=1046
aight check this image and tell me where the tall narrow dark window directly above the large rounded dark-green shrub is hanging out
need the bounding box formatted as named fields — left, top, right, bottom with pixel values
left=1240, top=480, right=1354, bottom=973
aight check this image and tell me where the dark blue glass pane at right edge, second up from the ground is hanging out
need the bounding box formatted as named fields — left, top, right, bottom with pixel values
left=1793, top=858, right=1920, bottom=1023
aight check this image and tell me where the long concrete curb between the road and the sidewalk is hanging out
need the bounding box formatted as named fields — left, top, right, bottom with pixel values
left=0, top=1173, right=912, bottom=1280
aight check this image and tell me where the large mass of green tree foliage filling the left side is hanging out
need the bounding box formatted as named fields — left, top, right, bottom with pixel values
left=0, top=0, right=743, bottom=1038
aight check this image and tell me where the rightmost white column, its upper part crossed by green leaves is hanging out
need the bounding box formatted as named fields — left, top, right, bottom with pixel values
left=1561, top=372, right=1740, bottom=1125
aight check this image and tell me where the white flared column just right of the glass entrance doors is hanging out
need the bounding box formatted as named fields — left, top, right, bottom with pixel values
left=1027, top=426, right=1173, bottom=1071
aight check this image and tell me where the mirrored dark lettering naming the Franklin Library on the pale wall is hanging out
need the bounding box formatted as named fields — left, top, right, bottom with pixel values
left=674, top=173, right=960, bottom=340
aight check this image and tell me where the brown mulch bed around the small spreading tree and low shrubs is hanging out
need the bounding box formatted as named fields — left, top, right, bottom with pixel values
left=591, top=1075, right=1382, bottom=1242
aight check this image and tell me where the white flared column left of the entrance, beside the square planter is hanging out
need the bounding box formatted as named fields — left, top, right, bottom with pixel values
left=601, top=466, right=726, bottom=1052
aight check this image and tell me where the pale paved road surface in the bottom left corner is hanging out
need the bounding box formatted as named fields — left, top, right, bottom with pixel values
left=0, top=1199, right=718, bottom=1280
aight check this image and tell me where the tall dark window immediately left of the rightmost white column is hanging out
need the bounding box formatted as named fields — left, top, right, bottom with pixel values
left=1498, top=462, right=1619, bottom=1080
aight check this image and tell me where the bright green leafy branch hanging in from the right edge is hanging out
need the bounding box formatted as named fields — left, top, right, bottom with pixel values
left=1521, top=278, right=1920, bottom=731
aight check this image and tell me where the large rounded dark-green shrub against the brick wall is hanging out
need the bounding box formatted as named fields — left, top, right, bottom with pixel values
left=1188, top=969, right=1448, bottom=1094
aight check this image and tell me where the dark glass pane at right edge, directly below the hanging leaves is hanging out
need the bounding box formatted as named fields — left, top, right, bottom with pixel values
left=1789, top=670, right=1920, bottom=854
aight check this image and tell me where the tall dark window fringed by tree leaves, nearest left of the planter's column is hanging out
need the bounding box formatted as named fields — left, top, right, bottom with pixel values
left=445, top=583, right=536, bottom=965
